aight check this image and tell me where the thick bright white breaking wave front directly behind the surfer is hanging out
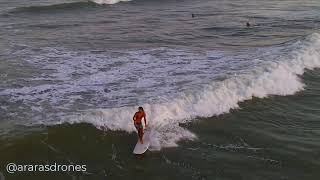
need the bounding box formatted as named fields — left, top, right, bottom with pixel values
left=69, top=34, right=320, bottom=149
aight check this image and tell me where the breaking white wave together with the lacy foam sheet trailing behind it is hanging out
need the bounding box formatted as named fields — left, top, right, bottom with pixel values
left=0, top=34, right=320, bottom=149
